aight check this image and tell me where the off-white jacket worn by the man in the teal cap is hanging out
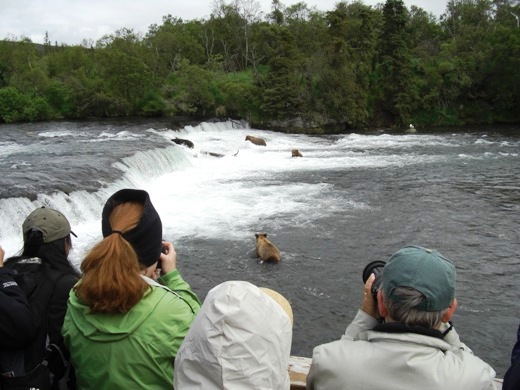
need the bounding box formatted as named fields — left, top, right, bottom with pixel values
left=307, top=310, right=495, bottom=390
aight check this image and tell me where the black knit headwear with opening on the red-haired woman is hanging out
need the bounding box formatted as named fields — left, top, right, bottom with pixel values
left=101, top=189, right=162, bottom=267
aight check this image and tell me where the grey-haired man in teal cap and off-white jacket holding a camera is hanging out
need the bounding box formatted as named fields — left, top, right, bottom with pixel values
left=307, top=246, right=495, bottom=390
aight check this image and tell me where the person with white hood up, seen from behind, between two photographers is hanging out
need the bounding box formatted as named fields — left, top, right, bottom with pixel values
left=174, top=281, right=293, bottom=390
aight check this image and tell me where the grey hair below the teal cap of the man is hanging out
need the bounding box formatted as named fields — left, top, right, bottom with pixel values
left=383, top=287, right=446, bottom=329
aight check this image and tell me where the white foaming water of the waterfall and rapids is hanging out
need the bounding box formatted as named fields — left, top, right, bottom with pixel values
left=0, top=122, right=464, bottom=263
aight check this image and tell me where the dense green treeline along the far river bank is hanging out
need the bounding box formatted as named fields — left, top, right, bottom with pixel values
left=0, top=0, right=520, bottom=131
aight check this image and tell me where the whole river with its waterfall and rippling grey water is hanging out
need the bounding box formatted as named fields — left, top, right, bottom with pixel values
left=0, top=120, right=520, bottom=376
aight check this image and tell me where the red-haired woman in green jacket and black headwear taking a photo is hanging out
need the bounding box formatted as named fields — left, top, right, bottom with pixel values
left=62, top=189, right=201, bottom=390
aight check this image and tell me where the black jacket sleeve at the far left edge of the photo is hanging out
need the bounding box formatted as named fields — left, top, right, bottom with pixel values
left=0, top=267, right=36, bottom=349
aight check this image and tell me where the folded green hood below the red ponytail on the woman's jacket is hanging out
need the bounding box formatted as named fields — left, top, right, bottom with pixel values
left=67, top=287, right=161, bottom=342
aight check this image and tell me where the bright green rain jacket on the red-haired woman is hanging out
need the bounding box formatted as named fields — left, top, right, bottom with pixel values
left=62, top=270, right=201, bottom=390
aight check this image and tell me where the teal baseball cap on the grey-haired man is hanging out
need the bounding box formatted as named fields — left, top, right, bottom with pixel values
left=382, top=245, right=456, bottom=311
